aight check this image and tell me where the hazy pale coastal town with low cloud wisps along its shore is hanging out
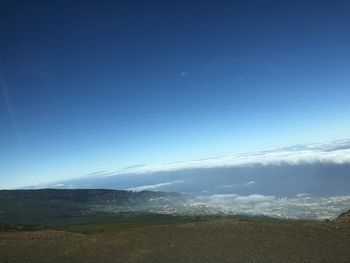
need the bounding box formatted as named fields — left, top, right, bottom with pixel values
left=162, top=194, right=350, bottom=220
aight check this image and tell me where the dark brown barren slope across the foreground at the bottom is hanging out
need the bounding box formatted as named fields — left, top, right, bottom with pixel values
left=0, top=220, right=350, bottom=263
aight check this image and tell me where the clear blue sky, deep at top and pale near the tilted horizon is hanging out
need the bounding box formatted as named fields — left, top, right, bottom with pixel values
left=0, top=0, right=350, bottom=188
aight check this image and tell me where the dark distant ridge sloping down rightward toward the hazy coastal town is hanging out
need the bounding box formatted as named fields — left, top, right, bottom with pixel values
left=0, top=189, right=181, bottom=224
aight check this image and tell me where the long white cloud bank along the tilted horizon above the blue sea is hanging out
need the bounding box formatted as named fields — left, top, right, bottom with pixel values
left=101, top=140, right=350, bottom=176
